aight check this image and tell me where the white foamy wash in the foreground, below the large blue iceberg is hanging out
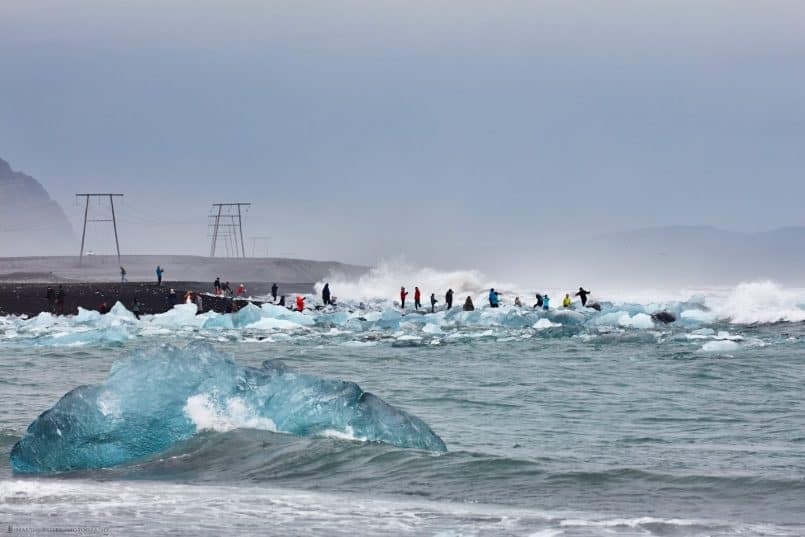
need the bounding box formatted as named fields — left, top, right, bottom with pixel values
left=0, top=479, right=803, bottom=537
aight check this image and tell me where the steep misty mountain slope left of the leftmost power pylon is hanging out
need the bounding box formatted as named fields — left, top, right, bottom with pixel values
left=0, top=159, right=74, bottom=255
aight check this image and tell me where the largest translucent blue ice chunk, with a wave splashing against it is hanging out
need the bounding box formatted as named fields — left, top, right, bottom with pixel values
left=11, top=342, right=446, bottom=473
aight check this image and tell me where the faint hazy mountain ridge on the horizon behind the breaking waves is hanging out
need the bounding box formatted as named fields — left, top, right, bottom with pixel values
left=494, top=226, right=805, bottom=290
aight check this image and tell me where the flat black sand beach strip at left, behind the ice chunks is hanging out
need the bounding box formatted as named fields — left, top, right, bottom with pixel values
left=0, top=281, right=313, bottom=317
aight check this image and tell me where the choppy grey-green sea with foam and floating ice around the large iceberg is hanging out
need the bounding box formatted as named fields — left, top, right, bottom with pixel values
left=0, top=283, right=805, bottom=536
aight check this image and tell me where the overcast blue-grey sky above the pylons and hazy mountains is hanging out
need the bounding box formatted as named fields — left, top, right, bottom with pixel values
left=0, top=0, right=805, bottom=270
